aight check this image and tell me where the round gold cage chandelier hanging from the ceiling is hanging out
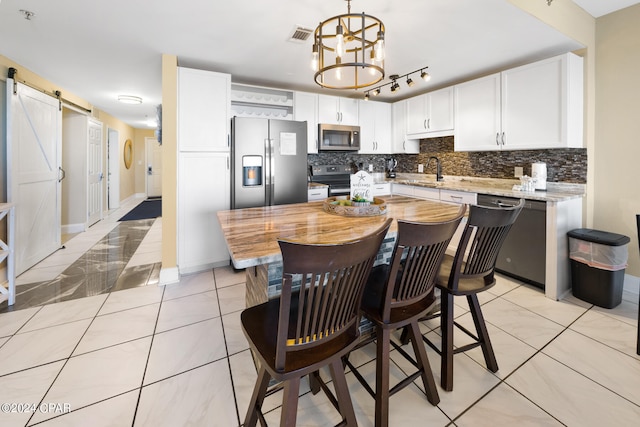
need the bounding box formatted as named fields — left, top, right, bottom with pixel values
left=312, top=0, right=385, bottom=89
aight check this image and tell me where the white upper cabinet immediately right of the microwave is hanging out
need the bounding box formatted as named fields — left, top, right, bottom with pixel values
left=359, top=100, right=391, bottom=154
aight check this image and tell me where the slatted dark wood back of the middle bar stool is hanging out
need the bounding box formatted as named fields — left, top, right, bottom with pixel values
left=381, top=205, right=467, bottom=323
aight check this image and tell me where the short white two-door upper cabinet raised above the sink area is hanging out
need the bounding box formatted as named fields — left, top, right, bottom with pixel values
left=407, top=87, right=454, bottom=138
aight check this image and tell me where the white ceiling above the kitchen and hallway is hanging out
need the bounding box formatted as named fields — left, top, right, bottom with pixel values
left=0, top=0, right=637, bottom=128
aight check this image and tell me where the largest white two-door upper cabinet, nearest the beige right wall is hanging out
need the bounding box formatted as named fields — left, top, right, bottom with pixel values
left=455, top=53, right=583, bottom=151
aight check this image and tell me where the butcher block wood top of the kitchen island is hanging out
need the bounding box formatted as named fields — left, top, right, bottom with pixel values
left=218, top=196, right=460, bottom=268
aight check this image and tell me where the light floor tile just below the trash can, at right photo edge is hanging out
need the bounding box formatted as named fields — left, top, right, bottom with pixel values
left=570, top=310, right=640, bottom=359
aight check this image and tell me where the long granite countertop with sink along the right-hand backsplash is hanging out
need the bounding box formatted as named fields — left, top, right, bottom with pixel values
left=374, top=173, right=585, bottom=202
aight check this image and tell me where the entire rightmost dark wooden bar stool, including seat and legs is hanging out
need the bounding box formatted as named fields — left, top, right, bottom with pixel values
left=423, top=199, right=524, bottom=391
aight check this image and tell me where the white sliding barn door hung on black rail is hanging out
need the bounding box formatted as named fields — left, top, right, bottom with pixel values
left=7, top=79, right=62, bottom=275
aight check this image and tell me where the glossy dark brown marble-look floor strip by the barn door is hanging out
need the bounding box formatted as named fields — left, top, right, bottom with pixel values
left=0, top=218, right=161, bottom=313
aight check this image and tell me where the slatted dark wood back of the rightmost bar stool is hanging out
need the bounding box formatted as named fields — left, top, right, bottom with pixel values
left=448, top=199, right=524, bottom=291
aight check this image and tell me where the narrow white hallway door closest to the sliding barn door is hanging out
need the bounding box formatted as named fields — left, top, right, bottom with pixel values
left=87, top=119, right=104, bottom=226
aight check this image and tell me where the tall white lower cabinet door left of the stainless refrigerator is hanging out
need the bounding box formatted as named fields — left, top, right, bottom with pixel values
left=178, top=152, right=231, bottom=274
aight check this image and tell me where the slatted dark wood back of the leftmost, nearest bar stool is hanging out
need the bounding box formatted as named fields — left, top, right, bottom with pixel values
left=275, top=218, right=392, bottom=370
